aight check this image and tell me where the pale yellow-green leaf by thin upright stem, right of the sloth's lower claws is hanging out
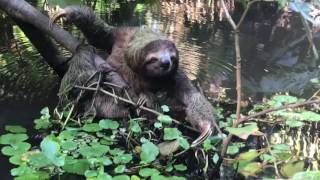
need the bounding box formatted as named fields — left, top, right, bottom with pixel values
left=226, top=123, right=259, bottom=140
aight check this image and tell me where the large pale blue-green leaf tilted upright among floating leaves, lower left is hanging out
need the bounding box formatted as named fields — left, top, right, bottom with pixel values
left=40, top=136, right=65, bottom=166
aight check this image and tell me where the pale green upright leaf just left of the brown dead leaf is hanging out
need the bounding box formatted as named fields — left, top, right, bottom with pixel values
left=140, top=141, right=159, bottom=164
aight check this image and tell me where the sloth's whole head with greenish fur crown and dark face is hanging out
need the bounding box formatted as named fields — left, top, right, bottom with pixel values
left=126, top=28, right=179, bottom=78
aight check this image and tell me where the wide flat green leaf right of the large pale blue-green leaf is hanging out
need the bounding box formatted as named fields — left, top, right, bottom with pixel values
left=79, top=144, right=110, bottom=157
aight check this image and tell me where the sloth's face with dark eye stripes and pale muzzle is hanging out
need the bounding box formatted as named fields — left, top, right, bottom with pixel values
left=141, top=40, right=179, bottom=78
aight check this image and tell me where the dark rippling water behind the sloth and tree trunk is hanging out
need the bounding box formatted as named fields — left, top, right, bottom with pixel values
left=0, top=1, right=320, bottom=177
